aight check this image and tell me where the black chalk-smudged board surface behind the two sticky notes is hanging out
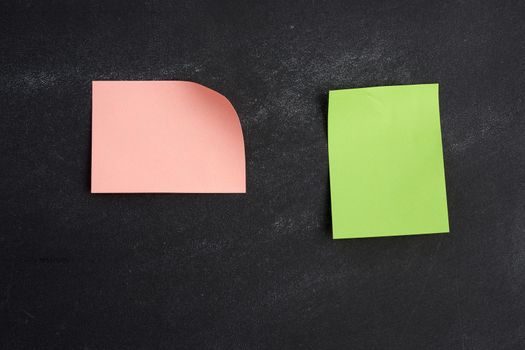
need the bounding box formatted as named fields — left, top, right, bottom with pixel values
left=0, top=0, right=525, bottom=350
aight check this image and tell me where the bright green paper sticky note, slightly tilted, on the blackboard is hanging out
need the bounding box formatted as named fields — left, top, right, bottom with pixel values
left=328, top=84, right=449, bottom=239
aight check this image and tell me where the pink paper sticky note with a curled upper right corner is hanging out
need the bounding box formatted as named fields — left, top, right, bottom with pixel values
left=91, top=81, right=246, bottom=193
